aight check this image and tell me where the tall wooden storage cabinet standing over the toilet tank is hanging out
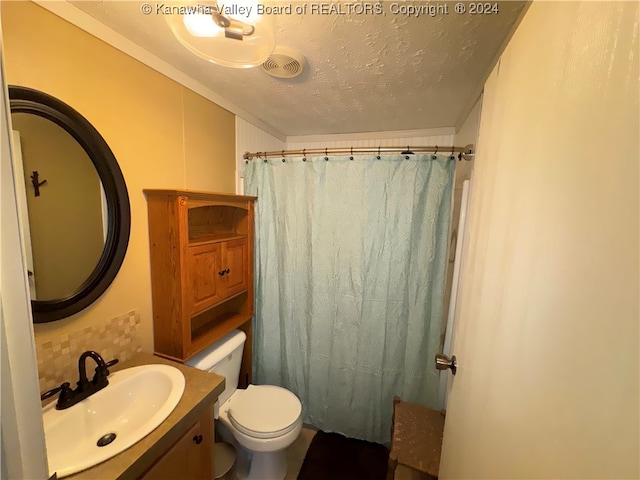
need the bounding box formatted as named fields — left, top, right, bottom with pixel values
left=144, top=190, right=256, bottom=387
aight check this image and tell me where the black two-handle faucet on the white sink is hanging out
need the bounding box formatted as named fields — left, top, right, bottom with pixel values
left=40, top=350, right=118, bottom=410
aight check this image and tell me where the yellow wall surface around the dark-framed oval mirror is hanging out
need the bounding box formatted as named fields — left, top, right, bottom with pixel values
left=1, top=2, right=235, bottom=351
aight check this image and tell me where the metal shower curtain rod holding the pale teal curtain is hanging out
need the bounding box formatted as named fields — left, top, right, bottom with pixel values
left=242, top=145, right=475, bottom=161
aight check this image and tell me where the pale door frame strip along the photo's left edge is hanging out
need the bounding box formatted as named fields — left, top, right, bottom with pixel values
left=0, top=18, right=49, bottom=479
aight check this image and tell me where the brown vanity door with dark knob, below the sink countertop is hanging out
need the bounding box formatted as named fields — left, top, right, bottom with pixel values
left=140, top=420, right=211, bottom=480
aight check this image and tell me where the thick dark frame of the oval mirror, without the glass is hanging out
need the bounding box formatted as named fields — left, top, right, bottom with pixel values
left=9, top=85, right=131, bottom=323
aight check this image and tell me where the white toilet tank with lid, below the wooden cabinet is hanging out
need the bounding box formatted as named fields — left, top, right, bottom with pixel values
left=186, top=330, right=247, bottom=412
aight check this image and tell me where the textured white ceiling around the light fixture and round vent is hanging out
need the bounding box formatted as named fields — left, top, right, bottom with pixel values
left=71, top=0, right=524, bottom=135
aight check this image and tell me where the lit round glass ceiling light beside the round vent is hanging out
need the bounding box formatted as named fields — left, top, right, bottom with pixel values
left=165, top=0, right=276, bottom=68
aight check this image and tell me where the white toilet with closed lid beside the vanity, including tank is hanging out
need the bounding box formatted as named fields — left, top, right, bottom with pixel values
left=187, top=330, right=302, bottom=480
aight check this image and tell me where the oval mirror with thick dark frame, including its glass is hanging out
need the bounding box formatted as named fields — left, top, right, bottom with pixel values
left=9, top=85, right=131, bottom=323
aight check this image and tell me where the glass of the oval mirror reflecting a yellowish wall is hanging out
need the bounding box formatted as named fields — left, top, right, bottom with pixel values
left=11, top=112, right=108, bottom=301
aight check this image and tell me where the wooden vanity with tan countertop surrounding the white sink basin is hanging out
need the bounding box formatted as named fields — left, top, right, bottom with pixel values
left=66, top=353, right=224, bottom=480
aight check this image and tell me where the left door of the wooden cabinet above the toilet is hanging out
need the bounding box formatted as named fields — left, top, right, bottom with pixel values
left=188, top=243, right=225, bottom=315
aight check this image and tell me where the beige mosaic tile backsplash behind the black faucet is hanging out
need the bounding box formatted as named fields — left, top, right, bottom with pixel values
left=36, top=310, right=142, bottom=392
